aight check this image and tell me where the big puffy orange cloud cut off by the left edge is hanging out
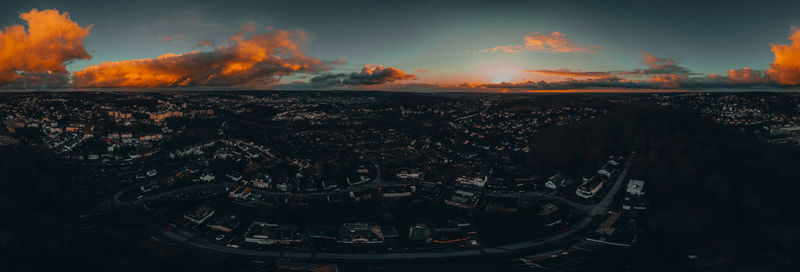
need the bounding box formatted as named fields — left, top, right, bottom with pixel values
left=0, top=9, right=92, bottom=85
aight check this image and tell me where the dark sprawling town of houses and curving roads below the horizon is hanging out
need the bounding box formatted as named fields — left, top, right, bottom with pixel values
left=0, top=92, right=800, bottom=269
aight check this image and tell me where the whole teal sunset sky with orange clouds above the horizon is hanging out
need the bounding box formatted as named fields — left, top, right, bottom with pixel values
left=0, top=0, right=800, bottom=91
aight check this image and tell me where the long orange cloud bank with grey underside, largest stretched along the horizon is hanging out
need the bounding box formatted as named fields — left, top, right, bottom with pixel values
left=73, top=24, right=325, bottom=87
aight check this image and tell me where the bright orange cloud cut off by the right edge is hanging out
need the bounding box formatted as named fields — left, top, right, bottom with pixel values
left=767, top=27, right=800, bottom=85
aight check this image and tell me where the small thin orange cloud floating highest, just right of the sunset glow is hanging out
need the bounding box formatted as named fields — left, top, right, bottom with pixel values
left=479, top=31, right=597, bottom=54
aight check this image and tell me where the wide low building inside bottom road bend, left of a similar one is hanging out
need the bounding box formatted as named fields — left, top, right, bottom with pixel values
left=244, top=221, right=302, bottom=245
